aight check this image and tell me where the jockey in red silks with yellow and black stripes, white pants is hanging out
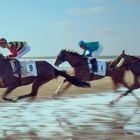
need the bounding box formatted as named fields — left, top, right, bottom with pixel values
left=0, top=38, right=30, bottom=59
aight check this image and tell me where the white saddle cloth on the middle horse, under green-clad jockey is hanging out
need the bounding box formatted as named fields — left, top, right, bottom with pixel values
left=88, top=60, right=106, bottom=76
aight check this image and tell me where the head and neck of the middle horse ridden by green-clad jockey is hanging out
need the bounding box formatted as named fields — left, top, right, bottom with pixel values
left=54, top=49, right=85, bottom=67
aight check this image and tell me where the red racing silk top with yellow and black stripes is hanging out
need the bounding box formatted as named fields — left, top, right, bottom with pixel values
left=7, top=41, right=27, bottom=58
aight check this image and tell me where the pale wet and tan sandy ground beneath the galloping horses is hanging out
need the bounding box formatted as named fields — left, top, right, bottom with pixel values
left=0, top=71, right=140, bottom=140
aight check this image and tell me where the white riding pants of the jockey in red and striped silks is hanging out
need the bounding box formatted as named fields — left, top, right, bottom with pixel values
left=16, top=44, right=30, bottom=59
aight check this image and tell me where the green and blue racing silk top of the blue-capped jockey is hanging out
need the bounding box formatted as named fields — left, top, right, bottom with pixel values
left=82, top=42, right=100, bottom=57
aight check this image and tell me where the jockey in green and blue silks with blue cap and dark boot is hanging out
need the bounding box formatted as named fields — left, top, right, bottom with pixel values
left=79, top=41, right=103, bottom=71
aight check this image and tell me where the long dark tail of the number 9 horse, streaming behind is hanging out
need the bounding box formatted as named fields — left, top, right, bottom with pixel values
left=55, top=69, right=90, bottom=87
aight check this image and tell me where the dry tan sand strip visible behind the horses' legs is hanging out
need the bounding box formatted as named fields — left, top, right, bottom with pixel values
left=0, top=72, right=133, bottom=100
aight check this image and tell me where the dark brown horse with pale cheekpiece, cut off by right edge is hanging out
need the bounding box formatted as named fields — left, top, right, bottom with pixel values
left=110, top=50, right=140, bottom=104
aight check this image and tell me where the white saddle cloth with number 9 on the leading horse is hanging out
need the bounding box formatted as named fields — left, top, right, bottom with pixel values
left=10, top=60, right=37, bottom=78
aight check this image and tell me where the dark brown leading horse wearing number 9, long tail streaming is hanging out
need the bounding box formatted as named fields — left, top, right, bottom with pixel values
left=0, top=54, right=90, bottom=101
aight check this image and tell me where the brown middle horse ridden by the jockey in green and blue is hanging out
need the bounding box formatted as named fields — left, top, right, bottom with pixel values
left=54, top=49, right=128, bottom=97
